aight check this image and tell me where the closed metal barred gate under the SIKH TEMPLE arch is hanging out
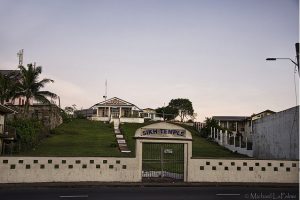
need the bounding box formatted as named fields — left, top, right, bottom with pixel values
left=142, top=143, right=184, bottom=181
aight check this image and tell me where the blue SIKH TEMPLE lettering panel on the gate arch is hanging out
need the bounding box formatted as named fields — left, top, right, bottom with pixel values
left=142, top=128, right=186, bottom=137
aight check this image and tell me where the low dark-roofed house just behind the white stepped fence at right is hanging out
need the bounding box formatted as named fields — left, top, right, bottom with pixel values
left=212, top=116, right=248, bottom=135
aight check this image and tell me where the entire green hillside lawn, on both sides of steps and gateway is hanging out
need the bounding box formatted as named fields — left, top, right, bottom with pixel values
left=18, top=119, right=246, bottom=158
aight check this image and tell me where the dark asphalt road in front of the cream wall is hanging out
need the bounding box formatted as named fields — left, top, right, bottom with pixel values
left=0, top=186, right=299, bottom=200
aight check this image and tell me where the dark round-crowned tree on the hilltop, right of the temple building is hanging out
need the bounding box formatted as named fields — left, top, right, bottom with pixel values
left=168, top=98, right=194, bottom=122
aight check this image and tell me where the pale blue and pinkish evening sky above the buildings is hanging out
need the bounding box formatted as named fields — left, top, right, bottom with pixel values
left=0, top=0, right=299, bottom=121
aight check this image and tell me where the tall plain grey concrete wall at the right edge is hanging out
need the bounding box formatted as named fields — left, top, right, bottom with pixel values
left=253, top=106, right=299, bottom=160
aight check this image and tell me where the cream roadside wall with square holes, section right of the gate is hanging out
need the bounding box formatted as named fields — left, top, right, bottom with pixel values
left=188, top=159, right=299, bottom=183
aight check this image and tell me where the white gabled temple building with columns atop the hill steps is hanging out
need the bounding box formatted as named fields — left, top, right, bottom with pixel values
left=88, top=97, right=144, bottom=123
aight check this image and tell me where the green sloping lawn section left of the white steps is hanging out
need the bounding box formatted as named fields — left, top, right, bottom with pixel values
left=21, top=119, right=126, bottom=156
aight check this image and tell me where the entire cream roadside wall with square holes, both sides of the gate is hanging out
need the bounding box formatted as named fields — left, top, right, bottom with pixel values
left=0, top=157, right=299, bottom=183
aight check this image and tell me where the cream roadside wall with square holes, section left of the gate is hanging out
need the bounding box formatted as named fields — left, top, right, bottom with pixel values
left=0, top=157, right=141, bottom=183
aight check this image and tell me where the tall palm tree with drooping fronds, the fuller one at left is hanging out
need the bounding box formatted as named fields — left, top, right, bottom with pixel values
left=15, top=64, right=57, bottom=113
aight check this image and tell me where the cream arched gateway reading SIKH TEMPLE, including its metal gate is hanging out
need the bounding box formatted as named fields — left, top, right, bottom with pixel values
left=135, top=122, right=192, bottom=182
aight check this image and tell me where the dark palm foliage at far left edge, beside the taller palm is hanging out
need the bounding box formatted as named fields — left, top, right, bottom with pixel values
left=0, top=72, right=16, bottom=104
